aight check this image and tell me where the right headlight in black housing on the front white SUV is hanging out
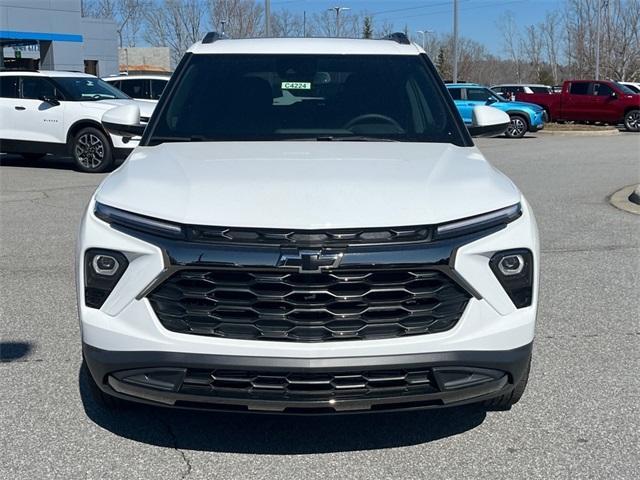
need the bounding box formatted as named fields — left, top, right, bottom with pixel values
left=489, top=249, right=533, bottom=308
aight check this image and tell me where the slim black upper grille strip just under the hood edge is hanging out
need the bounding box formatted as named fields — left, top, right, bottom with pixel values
left=188, top=225, right=433, bottom=247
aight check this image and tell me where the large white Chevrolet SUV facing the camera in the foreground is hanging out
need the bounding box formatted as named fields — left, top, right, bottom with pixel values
left=77, top=34, right=539, bottom=413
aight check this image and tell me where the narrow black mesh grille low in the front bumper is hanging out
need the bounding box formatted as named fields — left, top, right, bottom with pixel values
left=180, top=368, right=438, bottom=401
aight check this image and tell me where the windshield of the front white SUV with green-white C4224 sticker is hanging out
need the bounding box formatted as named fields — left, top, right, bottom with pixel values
left=147, top=54, right=464, bottom=145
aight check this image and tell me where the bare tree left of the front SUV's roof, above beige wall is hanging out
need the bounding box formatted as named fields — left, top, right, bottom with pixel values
left=144, top=0, right=207, bottom=65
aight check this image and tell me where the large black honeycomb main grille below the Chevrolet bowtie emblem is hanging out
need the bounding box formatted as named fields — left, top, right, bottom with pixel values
left=148, top=267, right=469, bottom=342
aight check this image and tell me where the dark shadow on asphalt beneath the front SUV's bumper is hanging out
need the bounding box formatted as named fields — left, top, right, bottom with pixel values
left=79, top=364, right=486, bottom=455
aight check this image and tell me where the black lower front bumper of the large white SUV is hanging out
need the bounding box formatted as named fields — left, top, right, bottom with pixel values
left=83, top=343, right=532, bottom=414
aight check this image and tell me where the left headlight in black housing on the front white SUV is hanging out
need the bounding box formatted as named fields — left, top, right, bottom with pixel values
left=84, top=248, right=129, bottom=308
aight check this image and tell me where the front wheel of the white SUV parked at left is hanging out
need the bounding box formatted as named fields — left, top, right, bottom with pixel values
left=71, top=127, right=113, bottom=173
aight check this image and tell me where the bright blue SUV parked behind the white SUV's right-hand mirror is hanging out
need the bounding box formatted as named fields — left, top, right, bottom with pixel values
left=447, top=83, right=546, bottom=138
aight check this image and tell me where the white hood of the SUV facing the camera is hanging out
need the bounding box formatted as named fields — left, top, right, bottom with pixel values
left=96, top=141, right=520, bottom=229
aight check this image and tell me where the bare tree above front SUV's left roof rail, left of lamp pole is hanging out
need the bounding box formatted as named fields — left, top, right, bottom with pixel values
left=209, top=0, right=264, bottom=38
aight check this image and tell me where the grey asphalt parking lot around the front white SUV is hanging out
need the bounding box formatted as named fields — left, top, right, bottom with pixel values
left=0, top=133, right=640, bottom=480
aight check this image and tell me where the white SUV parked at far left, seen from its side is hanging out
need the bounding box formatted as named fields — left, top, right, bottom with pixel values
left=0, top=70, right=154, bottom=172
